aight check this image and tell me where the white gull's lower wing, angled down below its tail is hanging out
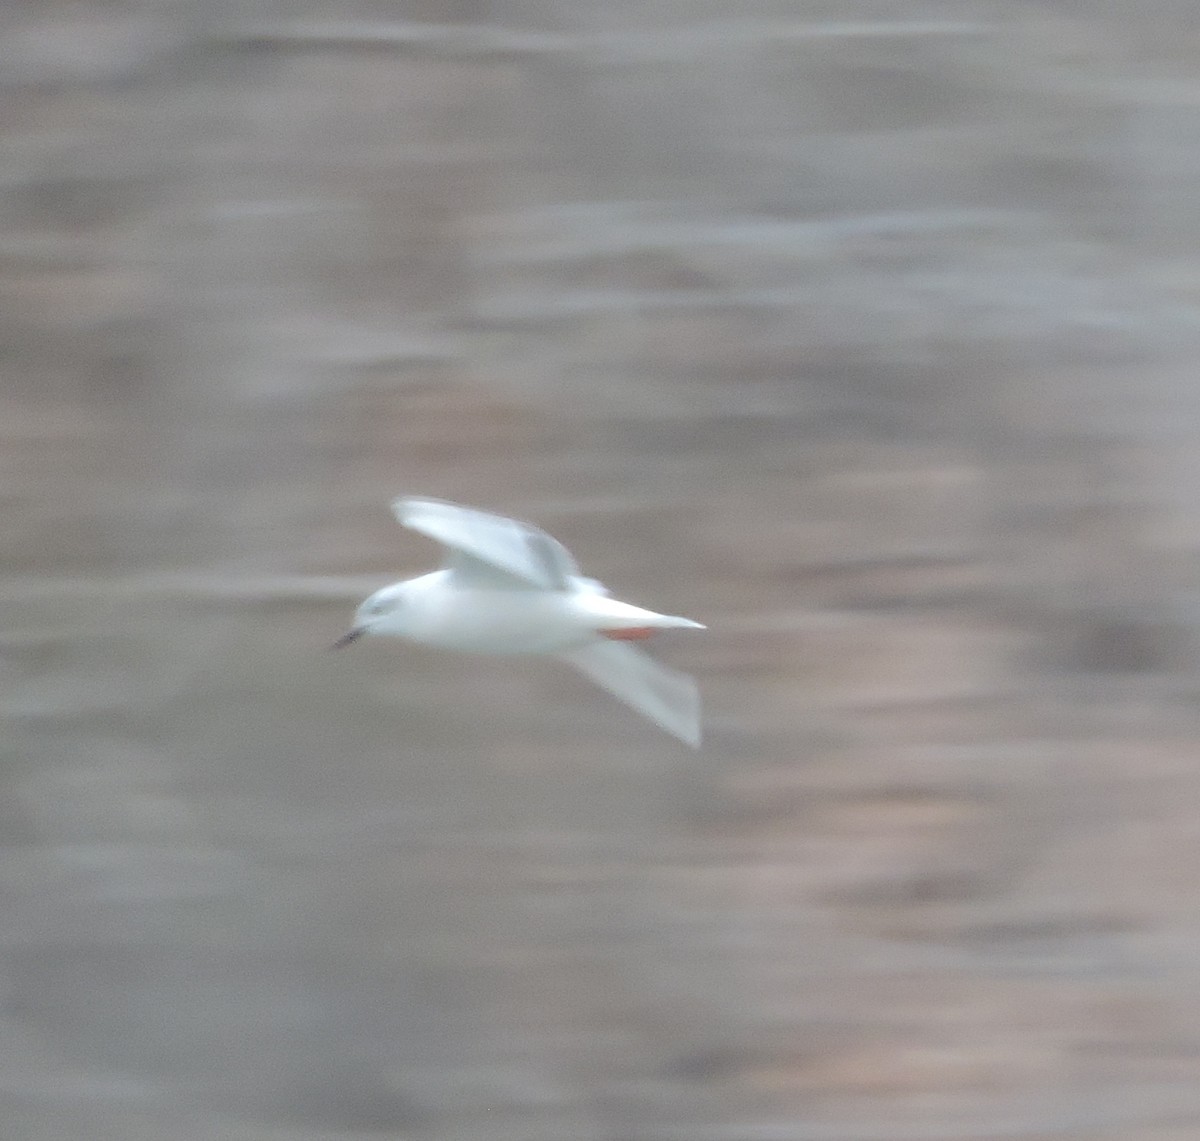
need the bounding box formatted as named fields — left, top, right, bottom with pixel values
left=558, top=642, right=700, bottom=749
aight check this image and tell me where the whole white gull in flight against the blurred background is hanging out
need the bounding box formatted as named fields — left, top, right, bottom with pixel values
left=334, top=497, right=704, bottom=749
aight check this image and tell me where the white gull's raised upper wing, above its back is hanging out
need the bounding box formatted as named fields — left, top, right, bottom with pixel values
left=391, top=498, right=580, bottom=590
